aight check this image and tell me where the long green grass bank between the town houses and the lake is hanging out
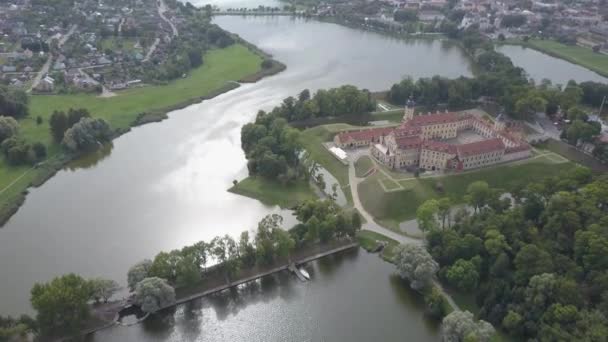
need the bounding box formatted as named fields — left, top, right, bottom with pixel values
left=0, top=45, right=262, bottom=223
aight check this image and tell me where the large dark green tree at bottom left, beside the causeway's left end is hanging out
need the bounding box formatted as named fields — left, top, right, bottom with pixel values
left=30, top=273, right=91, bottom=336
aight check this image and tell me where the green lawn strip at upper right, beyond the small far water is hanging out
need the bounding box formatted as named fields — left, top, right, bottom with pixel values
left=524, top=39, right=608, bottom=76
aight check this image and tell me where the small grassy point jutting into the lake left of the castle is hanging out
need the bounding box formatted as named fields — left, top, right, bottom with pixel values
left=229, top=177, right=317, bottom=208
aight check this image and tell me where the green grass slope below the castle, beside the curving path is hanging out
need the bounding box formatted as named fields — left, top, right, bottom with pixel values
left=359, top=156, right=574, bottom=231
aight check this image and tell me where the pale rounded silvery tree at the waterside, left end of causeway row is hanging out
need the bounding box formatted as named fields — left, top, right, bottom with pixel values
left=135, top=277, right=175, bottom=313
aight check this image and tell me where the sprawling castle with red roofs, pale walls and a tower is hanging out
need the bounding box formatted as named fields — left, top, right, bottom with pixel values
left=334, top=101, right=531, bottom=171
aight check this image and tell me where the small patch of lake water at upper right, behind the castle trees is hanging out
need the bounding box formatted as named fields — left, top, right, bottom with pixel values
left=496, top=45, right=608, bottom=85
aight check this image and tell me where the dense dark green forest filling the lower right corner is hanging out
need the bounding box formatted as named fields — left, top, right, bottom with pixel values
left=427, top=168, right=608, bottom=341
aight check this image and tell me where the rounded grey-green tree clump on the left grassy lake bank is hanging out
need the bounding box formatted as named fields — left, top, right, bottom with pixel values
left=61, top=118, right=112, bottom=152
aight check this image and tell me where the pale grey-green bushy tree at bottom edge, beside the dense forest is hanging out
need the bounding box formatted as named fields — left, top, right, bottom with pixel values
left=441, top=310, right=496, bottom=342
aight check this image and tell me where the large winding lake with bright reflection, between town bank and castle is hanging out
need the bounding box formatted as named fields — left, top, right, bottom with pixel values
left=0, top=17, right=471, bottom=316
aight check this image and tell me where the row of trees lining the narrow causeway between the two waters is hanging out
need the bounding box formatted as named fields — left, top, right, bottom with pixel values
left=127, top=200, right=361, bottom=312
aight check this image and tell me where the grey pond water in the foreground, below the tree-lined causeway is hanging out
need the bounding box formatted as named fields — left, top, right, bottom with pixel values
left=89, top=250, right=439, bottom=342
